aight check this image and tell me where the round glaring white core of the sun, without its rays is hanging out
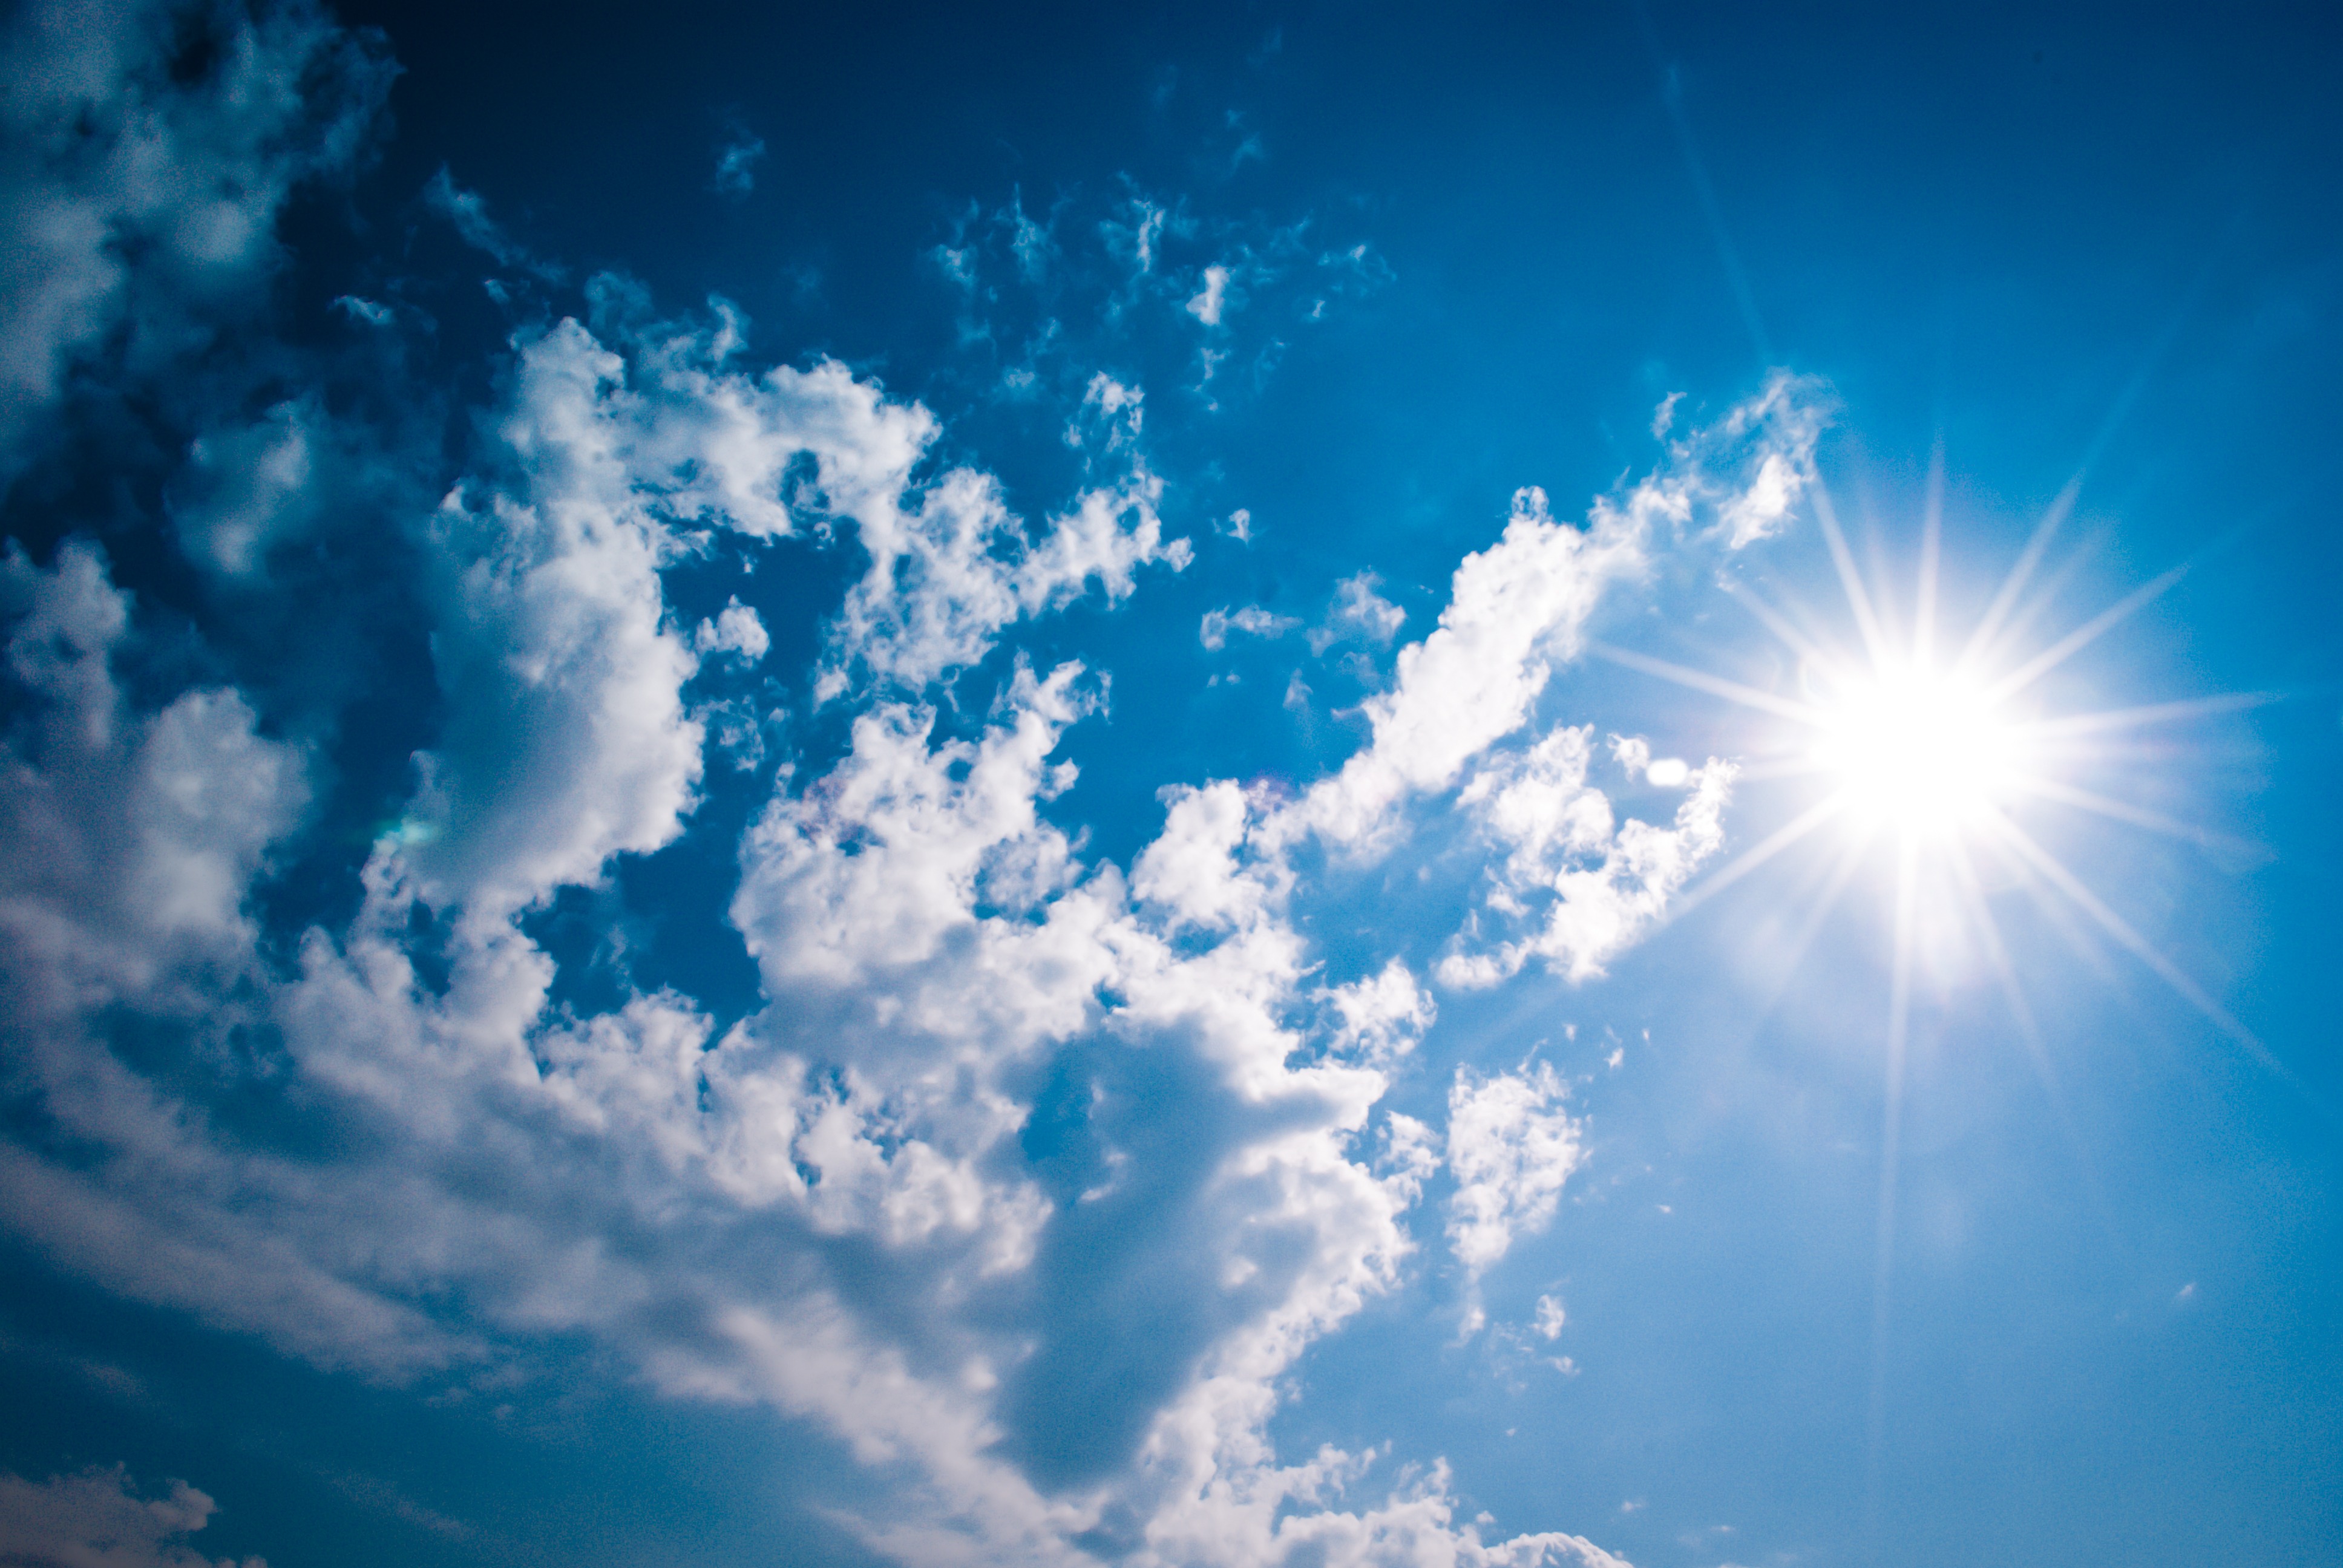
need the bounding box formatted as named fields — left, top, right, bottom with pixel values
left=1814, top=663, right=2017, bottom=837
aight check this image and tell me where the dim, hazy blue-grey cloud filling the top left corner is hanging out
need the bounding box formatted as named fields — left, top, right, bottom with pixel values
left=0, top=0, right=392, bottom=457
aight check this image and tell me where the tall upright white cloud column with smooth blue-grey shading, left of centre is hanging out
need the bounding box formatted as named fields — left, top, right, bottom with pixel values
left=382, top=321, right=703, bottom=921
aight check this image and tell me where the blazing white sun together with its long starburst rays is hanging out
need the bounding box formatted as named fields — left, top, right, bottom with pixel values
left=1593, top=457, right=2303, bottom=1507
